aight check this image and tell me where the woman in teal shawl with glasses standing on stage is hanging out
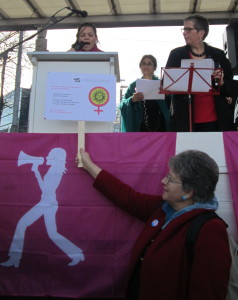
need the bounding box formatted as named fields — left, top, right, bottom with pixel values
left=120, top=55, right=169, bottom=132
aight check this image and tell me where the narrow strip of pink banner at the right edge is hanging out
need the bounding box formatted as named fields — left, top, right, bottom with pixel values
left=223, top=132, right=238, bottom=226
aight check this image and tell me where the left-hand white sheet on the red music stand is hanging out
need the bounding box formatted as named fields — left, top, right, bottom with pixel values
left=163, top=68, right=189, bottom=92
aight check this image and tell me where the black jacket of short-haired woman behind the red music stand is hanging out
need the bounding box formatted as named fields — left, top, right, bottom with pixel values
left=166, top=43, right=238, bottom=132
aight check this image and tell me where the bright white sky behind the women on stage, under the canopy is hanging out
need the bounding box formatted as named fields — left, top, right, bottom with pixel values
left=43, top=25, right=227, bottom=85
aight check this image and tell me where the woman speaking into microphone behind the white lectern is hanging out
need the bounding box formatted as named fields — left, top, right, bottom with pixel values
left=69, top=22, right=102, bottom=52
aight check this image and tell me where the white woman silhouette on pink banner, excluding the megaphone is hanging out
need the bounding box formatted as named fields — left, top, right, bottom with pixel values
left=1, top=148, right=84, bottom=268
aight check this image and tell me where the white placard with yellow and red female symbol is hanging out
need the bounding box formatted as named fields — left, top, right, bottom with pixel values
left=45, top=72, right=116, bottom=121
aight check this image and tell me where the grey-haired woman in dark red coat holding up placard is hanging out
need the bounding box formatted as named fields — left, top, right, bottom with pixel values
left=76, top=149, right=231, bottom=300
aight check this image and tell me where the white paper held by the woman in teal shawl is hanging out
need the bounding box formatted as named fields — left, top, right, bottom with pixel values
left=136, top=79, right=165, bottom=100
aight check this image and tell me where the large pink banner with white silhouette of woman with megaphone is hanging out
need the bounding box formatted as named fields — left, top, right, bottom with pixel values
left=0, top=133, right=176, bottom=298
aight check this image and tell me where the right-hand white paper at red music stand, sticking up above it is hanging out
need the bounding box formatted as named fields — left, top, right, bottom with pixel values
left=181, top=58, right=215, bottom=92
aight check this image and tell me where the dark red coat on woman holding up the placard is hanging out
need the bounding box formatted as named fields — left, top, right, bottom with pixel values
left=94, top=171, right=231, bottom=300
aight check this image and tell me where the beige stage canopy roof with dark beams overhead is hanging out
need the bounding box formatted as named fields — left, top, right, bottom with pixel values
left=0, top=0, right=238, bottom=31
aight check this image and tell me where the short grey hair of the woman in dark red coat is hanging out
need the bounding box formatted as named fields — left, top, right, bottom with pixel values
left=169, top=150, right=219, bottom=203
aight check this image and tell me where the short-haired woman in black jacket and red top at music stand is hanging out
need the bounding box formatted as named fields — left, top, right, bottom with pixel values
left=166, top=15, right=235, bottom=132
